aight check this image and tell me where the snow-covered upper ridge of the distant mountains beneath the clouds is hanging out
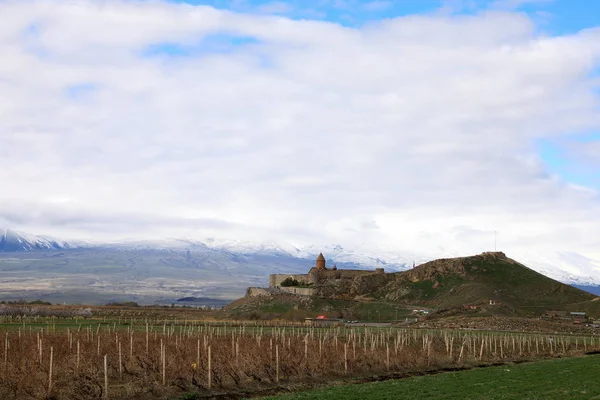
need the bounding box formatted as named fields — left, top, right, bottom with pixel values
left=0, top=229, right=600, bottom=285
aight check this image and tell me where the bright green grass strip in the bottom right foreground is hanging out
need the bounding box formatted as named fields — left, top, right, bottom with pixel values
left=264, top=356, right=600, bottom=400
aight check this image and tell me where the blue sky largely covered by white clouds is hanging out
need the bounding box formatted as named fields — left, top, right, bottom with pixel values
left=0, top=0, right=600, bottom=268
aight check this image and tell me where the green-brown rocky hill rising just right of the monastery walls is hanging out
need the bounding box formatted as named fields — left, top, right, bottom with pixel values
left=323, top=252, right=596, bottom=314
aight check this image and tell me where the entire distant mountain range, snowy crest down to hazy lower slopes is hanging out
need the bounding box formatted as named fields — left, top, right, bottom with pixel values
left=0, top=229, right=600, bottom=304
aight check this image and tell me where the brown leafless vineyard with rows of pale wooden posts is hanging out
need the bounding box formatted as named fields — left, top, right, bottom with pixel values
left=0, top=318, right=600, bottom=399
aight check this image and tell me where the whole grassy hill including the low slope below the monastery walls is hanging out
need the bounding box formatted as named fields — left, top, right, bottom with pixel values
left=229, top=252, right=600, bottom=320
